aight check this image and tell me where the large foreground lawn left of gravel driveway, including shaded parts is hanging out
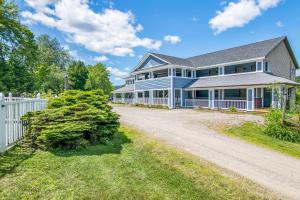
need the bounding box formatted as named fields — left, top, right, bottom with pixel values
left=0, top=127, right=274, bottom=199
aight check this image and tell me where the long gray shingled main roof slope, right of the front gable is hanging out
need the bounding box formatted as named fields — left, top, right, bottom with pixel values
left=187, top=37, right=286, bottom=67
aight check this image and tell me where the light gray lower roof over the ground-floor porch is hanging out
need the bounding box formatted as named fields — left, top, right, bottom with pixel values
left=186, top=72, right=300, bottom=88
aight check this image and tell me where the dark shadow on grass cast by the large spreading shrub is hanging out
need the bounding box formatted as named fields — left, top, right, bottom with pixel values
left=51, top=131, right=132, bottom=157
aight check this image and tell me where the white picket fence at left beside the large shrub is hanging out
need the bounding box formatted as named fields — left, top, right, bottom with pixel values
left=0, top=93, right=47, bottom=152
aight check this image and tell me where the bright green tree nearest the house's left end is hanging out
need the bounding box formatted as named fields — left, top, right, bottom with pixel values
left=85, top=63, right=113, bottom=95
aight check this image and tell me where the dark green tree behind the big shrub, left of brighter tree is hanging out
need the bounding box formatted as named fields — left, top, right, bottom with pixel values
left=68, top=61, right=89, bottom=90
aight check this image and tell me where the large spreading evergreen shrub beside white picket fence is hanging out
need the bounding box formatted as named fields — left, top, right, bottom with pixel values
left=23, top=90, right=119, bottom=149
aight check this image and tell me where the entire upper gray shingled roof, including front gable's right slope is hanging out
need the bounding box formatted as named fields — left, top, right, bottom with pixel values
left=145, top=36, right=299, bottom=68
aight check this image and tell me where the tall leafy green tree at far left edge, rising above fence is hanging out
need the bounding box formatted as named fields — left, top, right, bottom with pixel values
left=0, top=0, right=36, bottom=92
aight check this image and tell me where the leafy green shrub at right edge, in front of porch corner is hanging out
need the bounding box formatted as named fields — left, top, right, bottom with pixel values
left=264, top=109, right=300, bottom=142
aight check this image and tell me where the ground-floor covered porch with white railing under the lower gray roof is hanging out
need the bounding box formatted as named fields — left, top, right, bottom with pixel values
left=184, top=85, right=293, bottom=111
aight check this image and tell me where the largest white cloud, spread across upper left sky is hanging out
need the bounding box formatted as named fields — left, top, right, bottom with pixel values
left=21, top=0, right=162, bottom=56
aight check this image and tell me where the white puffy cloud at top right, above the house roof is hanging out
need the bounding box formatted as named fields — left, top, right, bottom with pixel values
left=209, top=0, right=280, bottom=34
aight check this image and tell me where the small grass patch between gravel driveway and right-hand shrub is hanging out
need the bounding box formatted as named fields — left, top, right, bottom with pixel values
left=223, top=122, right=300, bottom=158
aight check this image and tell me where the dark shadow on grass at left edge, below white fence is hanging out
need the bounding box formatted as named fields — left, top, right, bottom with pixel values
left=0, top=139, right=35, bottom=178
